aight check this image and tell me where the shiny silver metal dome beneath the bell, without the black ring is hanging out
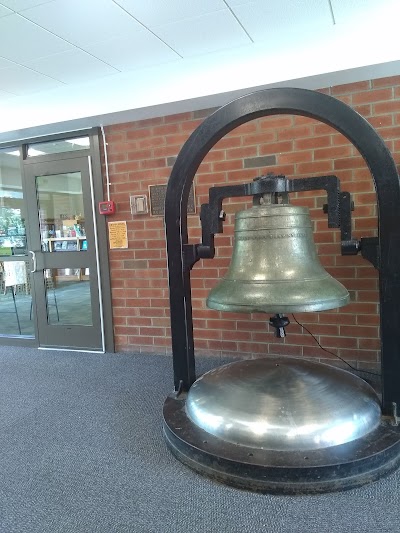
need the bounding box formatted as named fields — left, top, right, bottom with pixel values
left=186, top=357, right=381, bottom=451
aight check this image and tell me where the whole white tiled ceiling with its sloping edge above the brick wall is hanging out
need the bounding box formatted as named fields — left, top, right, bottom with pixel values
left=0, top=0, right=400, bottom=141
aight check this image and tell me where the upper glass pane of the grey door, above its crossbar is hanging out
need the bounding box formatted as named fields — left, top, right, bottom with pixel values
left=36, top=172, right=87, bottom=252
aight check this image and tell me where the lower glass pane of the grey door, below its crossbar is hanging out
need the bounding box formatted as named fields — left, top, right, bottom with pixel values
left=44, top=268, right=93, bottom=326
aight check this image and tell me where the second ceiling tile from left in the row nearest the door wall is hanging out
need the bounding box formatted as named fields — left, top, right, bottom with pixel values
left=24, top=49, right=118, bottom=83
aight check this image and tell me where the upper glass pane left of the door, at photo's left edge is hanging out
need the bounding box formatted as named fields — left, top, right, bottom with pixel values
left=0, top=148, right=27, bottom=256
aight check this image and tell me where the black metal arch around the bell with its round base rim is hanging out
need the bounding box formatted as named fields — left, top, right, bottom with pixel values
left=164, top=88, right=400, bottom=492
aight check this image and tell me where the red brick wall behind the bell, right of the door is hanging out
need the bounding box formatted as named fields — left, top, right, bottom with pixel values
left=105, top=76, right=400, bottom=368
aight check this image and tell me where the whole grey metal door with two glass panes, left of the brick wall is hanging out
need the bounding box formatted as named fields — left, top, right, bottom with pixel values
left=25, top=157, right=104, bottom=350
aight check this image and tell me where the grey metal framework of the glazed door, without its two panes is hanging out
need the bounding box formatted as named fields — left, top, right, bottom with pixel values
left=24, top=156, right=104, bottom=351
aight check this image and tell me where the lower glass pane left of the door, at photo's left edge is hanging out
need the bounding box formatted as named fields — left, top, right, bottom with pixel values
left=0, top=258, right=34, bottom=337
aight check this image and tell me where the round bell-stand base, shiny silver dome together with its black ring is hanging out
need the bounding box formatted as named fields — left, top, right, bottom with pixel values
left=163, top=358, right=400, bottom=494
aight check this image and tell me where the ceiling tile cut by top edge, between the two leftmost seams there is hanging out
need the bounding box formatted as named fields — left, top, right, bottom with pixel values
left=115, top=0, right=226, bottom=28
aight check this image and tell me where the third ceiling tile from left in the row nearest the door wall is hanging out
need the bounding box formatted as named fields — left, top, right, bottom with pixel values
left=85, top=29, right=179, bottom=71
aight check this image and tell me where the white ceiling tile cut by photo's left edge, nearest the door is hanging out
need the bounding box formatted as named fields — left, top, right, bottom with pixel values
left=0, top=66, right=64, bottom=95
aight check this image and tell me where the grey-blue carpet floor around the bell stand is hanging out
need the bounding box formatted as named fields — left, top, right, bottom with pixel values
left=0, top=347, right=400, bottom=533
